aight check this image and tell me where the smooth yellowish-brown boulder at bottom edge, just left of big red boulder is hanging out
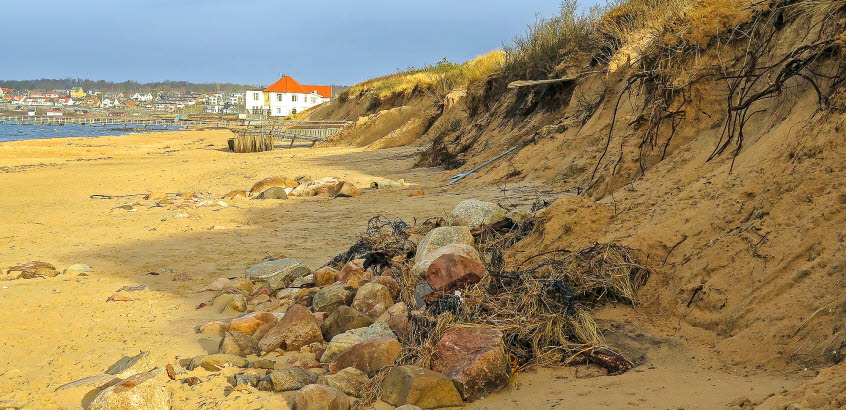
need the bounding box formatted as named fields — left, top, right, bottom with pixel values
left=381, top=366, right=464, bottom=409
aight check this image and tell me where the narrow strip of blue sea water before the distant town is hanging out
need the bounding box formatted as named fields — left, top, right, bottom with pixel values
left=0, top=123, right=179, bottom=142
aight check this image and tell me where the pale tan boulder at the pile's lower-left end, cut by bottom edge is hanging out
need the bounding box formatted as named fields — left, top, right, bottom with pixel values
left=88, top=370, right=170, bottom=410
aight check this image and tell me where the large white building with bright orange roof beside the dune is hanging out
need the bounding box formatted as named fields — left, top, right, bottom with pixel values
left=246, top=76, right=332, bottom=117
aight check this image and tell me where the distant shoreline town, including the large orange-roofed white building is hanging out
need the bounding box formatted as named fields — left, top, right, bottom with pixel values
left=0, top=76, right=345, bottom=117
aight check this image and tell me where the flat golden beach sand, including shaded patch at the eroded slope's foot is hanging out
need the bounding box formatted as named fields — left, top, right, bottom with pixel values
left=0, top=131, right=813, bottom=408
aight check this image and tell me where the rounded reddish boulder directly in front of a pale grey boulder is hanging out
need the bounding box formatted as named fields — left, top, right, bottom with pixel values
left=425, top=250, right=488, bottom=292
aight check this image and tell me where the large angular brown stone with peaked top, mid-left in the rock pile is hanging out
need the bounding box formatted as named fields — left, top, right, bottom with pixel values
left=259, top=304, right=323, bottom=352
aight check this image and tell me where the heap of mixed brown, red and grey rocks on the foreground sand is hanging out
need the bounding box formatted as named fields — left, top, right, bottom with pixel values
left=48, top=198, right=528, bottom=409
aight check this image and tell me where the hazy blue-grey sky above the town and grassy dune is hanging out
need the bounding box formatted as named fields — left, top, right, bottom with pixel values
left=0, top=0, right=600, bottom=85
